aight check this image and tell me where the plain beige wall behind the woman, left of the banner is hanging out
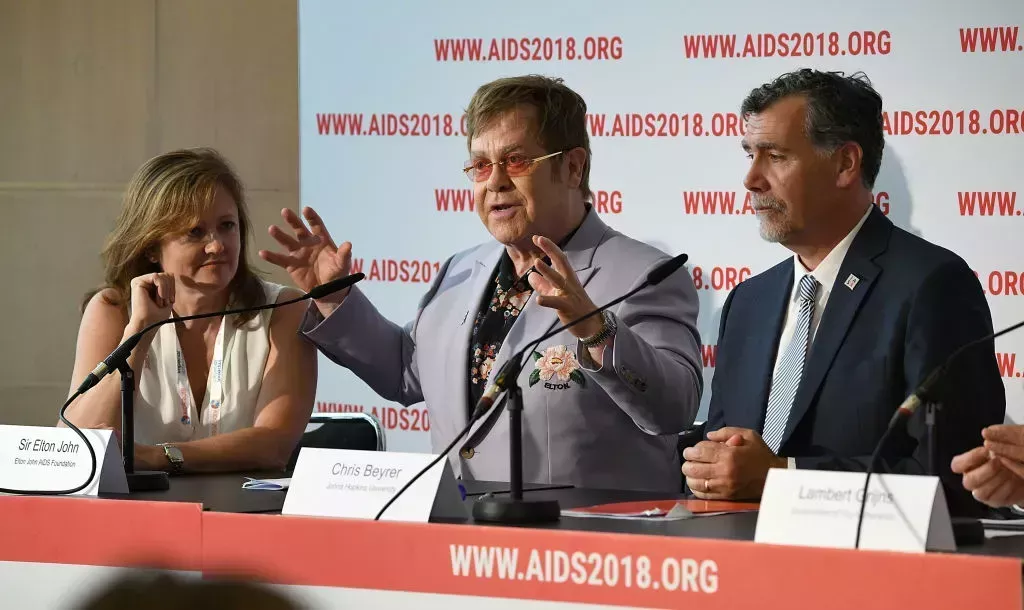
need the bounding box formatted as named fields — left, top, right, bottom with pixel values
left=0, top=0, right=299, bottom=425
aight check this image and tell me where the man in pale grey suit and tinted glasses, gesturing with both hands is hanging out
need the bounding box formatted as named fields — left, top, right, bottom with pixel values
left=260, top=76, right=703, bottom=492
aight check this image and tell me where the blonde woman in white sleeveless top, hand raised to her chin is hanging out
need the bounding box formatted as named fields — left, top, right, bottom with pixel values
left=67, top=148, right=316, bottom=474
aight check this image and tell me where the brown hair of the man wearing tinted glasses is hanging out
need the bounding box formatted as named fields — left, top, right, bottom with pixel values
left=466, top=75, right=591, bottom=200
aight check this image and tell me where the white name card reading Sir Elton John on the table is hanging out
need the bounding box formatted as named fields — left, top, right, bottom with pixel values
left=0, top=425, right=128, bottom=495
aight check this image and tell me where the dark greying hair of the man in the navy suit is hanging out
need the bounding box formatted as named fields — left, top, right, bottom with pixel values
left=740, top=68, right=886, bottom=188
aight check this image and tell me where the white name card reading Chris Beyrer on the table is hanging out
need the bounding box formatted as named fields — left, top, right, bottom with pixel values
left=281, top=447, right=468, bottom=523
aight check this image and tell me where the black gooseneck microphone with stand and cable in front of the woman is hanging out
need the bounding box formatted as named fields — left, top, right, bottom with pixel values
left=20, top=273, right=365, bottom=495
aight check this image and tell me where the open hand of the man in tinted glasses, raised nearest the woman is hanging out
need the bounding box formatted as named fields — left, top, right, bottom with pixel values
left=259, top=208, right=352, bottom=316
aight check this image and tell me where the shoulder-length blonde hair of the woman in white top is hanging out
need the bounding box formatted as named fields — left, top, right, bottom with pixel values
left=82, top=148, right=266, bottom=325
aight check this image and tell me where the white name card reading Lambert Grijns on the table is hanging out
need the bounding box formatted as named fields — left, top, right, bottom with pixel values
left=754, top=469, right=956, bottom=553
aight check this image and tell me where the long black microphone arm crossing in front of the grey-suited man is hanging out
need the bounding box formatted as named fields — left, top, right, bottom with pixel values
left=374, top=254, right=688, bottom=521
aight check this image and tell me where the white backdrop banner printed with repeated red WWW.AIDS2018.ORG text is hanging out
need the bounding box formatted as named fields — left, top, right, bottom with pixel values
left=299, top=0, right=1024, bottom=451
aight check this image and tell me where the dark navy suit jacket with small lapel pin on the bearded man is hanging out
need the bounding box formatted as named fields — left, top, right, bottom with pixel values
left=707, top=204, right=1006, bottom=515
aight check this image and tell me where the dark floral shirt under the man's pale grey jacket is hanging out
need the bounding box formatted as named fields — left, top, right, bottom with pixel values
left=469, top=253, right=534, bottom=412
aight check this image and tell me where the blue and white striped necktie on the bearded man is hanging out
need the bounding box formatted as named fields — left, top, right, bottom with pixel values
left=761, top=273, right=819, bottom=453
